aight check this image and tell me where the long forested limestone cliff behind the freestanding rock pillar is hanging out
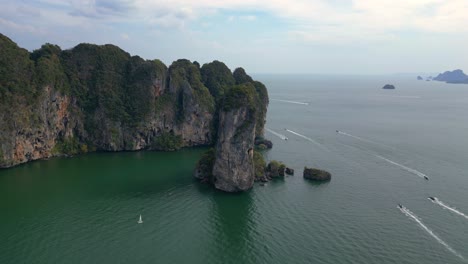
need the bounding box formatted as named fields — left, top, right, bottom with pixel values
left=0, top=34, right=268, bottom=167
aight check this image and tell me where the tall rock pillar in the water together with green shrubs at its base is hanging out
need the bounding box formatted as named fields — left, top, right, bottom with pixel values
left=194, top=82, right=266, bottom=192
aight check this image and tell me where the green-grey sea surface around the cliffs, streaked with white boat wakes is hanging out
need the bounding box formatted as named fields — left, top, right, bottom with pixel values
left=0, top=75, right=468, bottom=264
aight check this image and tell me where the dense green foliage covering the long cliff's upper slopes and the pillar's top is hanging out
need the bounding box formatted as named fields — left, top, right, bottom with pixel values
left=0, top=34, right=268, bottom=161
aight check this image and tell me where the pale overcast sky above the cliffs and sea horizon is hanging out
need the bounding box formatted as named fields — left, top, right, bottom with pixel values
left=0, top=0, right=468, bottom=74
